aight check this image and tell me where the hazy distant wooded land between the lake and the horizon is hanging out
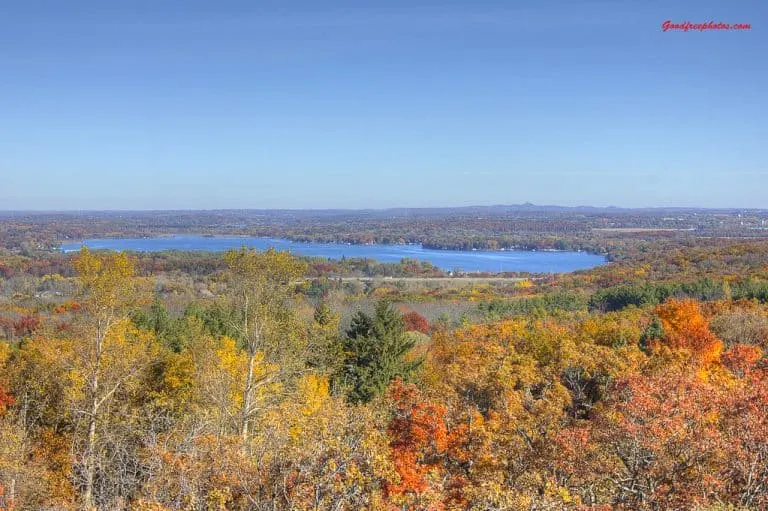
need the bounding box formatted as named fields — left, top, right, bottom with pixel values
left=0, top=204, right=768, bottom=258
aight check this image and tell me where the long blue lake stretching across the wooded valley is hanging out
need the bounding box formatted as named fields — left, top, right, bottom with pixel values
left=61, top=236, right=605, bottom=273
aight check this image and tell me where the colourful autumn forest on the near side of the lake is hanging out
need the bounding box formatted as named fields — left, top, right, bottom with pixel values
left=0, top=229, right=768, bottom=511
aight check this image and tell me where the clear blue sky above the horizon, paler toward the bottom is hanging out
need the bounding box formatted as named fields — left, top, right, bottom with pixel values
left=0, top=0, right=768, bottom=210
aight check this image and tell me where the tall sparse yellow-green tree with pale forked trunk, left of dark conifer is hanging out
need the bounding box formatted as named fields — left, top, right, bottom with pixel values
left=225, top=248, right=306, bottom=445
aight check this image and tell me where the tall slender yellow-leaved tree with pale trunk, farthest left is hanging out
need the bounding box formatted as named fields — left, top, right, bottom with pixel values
left=71, top=247, right=151, bottom=509
